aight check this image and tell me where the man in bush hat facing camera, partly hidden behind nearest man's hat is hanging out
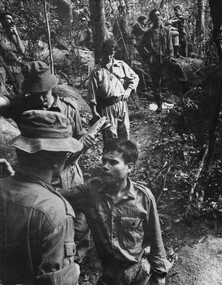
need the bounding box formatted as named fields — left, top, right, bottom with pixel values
left=0, top=61, right=94, bottom=262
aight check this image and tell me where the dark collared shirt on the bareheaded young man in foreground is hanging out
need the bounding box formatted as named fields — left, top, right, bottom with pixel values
left=63, top=179, right=168, bottom=276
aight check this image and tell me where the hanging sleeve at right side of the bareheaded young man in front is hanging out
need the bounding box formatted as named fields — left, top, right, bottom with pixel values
left=145, top=193, right=171, bottom=279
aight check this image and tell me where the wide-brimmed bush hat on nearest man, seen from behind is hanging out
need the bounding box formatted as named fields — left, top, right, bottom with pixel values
left=11, top=110, right=83, bottom=153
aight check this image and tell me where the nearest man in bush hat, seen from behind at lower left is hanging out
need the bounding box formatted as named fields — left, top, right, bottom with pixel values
left=0, top=110, right=83, bottom=285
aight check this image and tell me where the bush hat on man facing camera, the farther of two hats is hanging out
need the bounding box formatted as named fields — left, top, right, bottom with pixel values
left=22, top=60, right=59, bottom=94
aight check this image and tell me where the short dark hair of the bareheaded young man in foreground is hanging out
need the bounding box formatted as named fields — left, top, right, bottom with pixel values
left=103, top=138, right=138, bottom=164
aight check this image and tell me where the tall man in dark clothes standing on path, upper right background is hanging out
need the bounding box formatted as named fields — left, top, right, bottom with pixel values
left=139, top=9, right=189, bottom=113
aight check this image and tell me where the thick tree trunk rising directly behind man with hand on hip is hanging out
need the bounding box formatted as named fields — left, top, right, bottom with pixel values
left=89, top=0, right=105, bottom=63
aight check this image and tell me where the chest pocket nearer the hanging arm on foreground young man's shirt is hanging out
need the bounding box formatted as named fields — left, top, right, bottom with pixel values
left=119, top=217, right=144, bottom=251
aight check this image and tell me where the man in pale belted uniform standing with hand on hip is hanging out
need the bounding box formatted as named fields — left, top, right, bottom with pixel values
left=88, top=39, right=139, bottom=141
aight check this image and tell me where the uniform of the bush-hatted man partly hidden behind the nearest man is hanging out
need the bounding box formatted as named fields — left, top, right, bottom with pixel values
left=2, top=93, right=90, bottom=260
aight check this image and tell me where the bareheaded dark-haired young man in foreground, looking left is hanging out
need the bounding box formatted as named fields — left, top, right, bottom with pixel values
left=63, top=139, right=171, bottom=285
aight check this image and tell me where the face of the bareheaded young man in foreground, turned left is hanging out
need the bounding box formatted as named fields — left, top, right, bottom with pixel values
left=102, top=151, right=134, bottom=184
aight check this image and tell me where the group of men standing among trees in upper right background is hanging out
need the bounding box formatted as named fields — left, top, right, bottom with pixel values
left=101, top=5, right=190, bottom=113
